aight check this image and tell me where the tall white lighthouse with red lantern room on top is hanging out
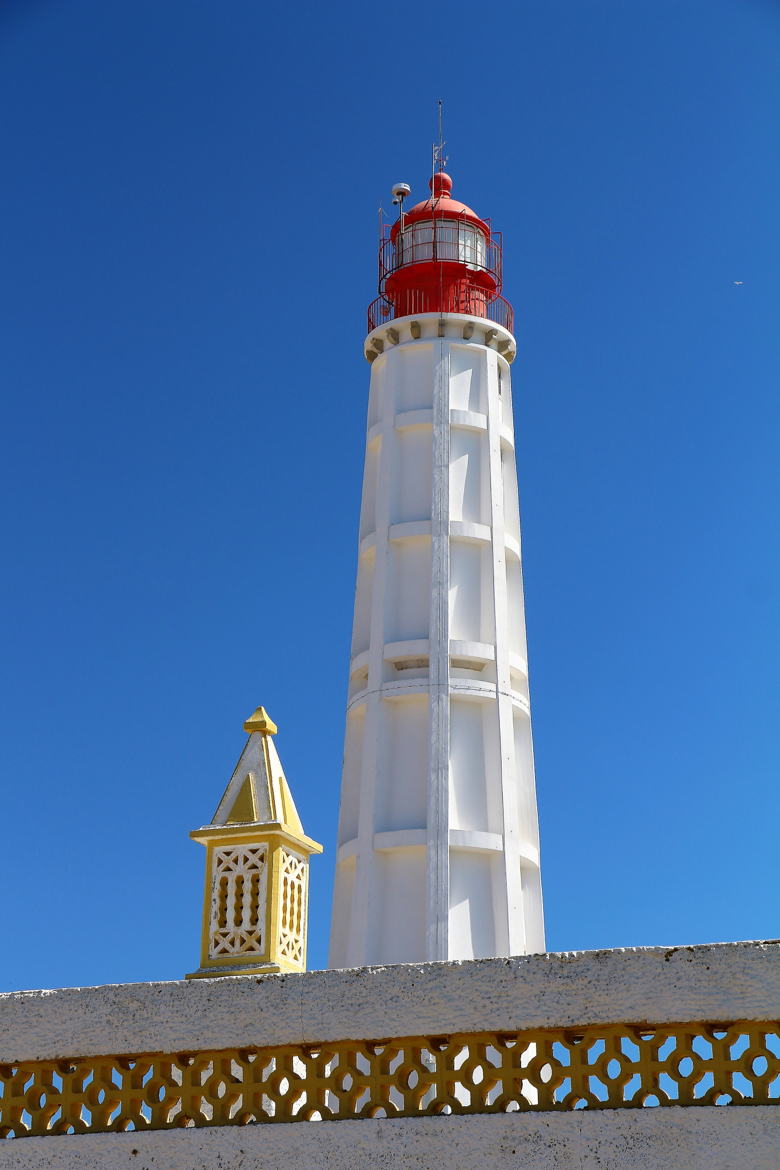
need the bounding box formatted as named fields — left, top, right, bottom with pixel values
left=330, top=171, right=544, bottom=968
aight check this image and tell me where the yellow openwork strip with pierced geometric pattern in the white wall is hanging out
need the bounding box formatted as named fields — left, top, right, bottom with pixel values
left=0, top=1023, right=780, bottom=1137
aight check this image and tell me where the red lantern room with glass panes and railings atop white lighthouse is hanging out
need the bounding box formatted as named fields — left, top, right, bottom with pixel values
left=368, top=171, right=513, bottom=332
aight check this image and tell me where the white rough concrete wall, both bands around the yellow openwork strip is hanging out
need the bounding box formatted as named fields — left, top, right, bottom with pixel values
left=0, top=942, right=780, bottom=1170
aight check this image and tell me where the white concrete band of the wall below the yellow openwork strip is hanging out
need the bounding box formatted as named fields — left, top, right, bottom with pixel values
left=0, top=1106, right=780, bottom=1170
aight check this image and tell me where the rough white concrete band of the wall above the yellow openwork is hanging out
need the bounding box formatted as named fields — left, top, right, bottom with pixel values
left=0, top=942, right=780, bottom=1067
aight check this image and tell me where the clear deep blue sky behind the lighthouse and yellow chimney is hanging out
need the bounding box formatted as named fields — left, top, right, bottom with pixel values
left=0, top=0, right=780, bottom=990
